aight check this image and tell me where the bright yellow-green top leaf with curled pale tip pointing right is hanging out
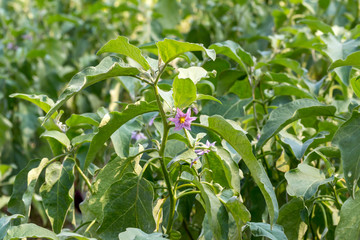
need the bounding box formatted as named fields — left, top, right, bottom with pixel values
left=156, top=39, right=216, bottom=63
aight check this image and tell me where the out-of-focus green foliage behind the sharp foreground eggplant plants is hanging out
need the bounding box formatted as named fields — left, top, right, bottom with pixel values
left=0, top=0, right=360, bottom=236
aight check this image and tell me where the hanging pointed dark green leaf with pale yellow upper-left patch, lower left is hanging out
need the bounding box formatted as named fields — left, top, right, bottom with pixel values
left=40, top=158, right=75, bottom=233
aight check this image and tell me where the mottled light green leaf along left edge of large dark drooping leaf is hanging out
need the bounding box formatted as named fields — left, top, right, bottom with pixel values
left=80, top=157, right=135, bottom=221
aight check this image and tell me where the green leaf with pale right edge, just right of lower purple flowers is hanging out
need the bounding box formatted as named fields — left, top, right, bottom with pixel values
left=206, top=147, right=240, bottom=193
